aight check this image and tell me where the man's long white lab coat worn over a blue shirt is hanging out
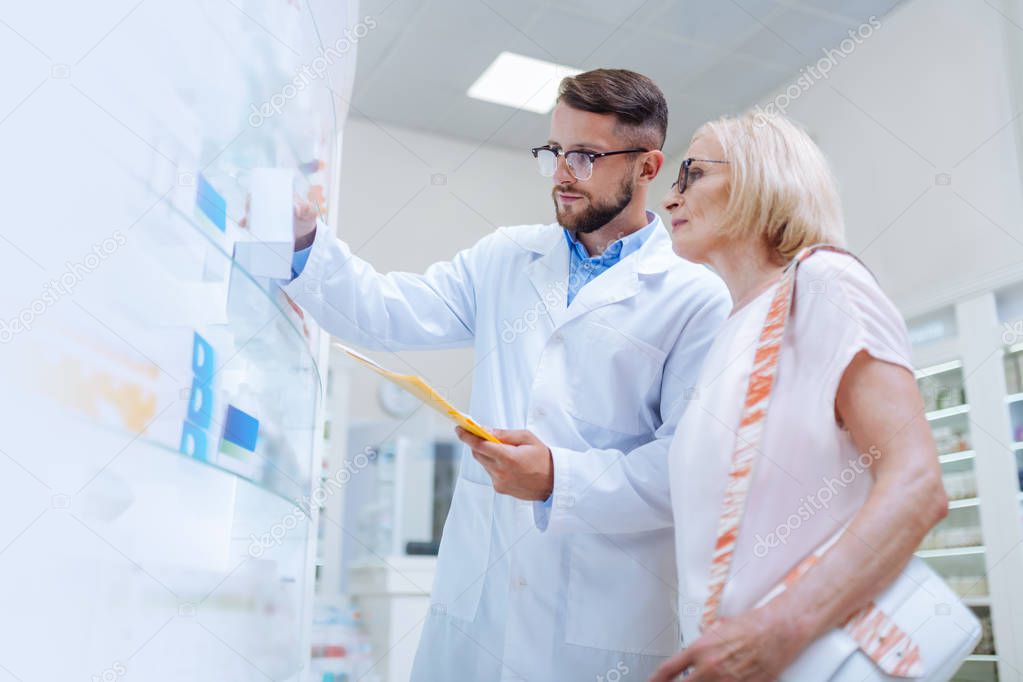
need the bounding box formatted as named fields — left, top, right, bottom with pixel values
left=284, top=220, right=730, bottom=682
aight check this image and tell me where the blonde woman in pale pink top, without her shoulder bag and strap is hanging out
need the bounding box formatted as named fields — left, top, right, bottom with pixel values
left=652, top=115, right=947, bottom=682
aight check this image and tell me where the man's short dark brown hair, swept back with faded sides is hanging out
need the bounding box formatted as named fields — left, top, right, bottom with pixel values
left=558, top=69, right=668, bottom=149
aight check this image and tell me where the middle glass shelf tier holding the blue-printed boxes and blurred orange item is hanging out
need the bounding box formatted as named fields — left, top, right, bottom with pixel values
left=6, top=194, right=321, bottom=500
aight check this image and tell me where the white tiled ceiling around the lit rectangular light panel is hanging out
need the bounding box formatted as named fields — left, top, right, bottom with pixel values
left=351, top=0, right=901, bottom=153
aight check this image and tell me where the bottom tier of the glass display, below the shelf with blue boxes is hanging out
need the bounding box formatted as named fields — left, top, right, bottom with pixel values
left=0, top=408, right=313, bottom=682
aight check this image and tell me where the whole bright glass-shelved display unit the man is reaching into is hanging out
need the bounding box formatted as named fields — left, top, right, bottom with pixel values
left=0, top=0, right=356, bottom=682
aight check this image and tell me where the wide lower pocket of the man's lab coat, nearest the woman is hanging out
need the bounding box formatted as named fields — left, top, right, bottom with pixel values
left=565, top=529, right=680, bottom=656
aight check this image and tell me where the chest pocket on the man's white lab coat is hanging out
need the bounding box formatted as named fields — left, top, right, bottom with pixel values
left=566, top=320, right=667, bottom=437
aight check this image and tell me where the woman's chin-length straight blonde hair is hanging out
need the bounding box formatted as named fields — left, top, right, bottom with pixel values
left=693, top=111, right=845, bottom=263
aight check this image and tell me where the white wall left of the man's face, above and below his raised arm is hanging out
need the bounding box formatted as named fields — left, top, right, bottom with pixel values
left=339, top=117, right=553, bottom=420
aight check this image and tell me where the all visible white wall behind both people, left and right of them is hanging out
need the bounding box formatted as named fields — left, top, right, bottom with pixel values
left=329, top=0, right=1023, bottom=427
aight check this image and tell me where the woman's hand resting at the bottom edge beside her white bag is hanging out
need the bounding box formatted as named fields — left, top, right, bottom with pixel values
left=650, top=603, right=810, bottom=682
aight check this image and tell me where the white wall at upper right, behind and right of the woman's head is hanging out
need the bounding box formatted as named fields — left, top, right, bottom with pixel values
left=744, top=0, right=1023, bottom=314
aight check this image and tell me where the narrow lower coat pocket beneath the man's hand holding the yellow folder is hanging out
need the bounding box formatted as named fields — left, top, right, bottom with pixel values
left=430, top=478, right=494, bottom=621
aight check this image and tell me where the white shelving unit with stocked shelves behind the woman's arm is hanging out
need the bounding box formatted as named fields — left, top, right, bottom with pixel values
left=908, top=287, right=1023, bottom=682
